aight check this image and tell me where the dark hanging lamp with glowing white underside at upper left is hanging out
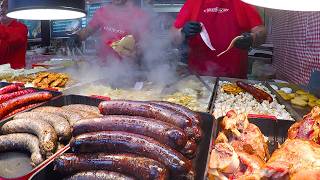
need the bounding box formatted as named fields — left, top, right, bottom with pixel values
left=7, top=0, right=86, bottom=20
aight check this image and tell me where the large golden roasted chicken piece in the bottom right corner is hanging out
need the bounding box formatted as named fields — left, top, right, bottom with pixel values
left=263, top=139, right=320, bottom=179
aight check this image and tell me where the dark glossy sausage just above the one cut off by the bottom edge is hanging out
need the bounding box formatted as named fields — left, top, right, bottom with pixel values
left=54, top=153, right=168, bottom=180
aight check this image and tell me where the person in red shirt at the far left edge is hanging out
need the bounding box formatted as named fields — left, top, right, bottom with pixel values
left=0, top=0, right=28, bottom=69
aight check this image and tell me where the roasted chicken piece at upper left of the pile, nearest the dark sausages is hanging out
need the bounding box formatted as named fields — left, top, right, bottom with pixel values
left=216, top=111, right=269, bottom=160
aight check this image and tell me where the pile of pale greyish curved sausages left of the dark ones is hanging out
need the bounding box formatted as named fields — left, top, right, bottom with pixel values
left=0, top=104, right=101, bottom=166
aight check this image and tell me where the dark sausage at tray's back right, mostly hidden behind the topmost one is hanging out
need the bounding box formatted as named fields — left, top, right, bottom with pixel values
left=151, top=101, right=202, bottom=142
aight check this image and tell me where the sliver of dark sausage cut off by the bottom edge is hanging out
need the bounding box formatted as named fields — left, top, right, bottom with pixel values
left=64, top=170, right=134, bottom=180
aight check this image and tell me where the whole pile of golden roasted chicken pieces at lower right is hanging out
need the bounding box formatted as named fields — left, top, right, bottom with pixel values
left=208, top=107, right=320, bottom=180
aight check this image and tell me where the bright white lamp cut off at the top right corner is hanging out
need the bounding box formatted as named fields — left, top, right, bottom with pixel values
left=242, top=0, right=320, bottom=11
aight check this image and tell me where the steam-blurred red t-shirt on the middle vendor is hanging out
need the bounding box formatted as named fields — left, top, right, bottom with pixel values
left=89, top=5, right=149, bottom=62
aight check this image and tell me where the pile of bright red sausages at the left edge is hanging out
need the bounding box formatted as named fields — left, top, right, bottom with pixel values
left=0, top=84, right=52, bottom=119
